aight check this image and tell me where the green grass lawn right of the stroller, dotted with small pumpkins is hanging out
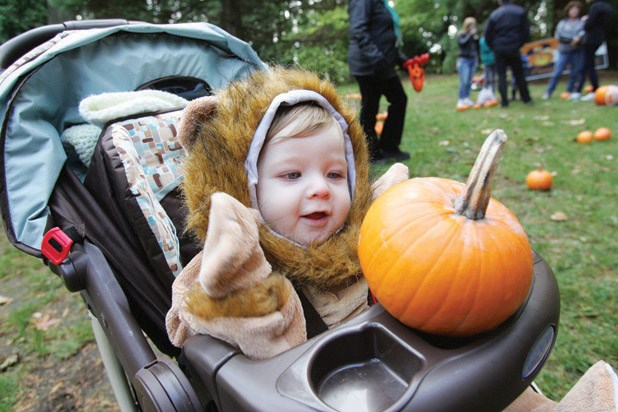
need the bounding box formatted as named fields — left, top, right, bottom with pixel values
left=342, top=72, right=618, bottom=399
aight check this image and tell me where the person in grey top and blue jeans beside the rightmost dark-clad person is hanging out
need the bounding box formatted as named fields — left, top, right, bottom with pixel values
left=543, top=1, right=584, bottom=100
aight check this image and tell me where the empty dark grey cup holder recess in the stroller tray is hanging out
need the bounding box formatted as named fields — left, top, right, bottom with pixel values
left=309, top=324, right=423, bottom=412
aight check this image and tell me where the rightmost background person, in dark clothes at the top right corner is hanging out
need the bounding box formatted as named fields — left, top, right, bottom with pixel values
left=574, top=0, right=613, bottom=100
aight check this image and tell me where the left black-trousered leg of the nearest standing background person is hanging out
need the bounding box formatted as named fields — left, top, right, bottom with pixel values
left=356, top=76, right=383, bottom=160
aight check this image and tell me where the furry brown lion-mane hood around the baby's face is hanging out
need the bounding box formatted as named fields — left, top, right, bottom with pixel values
left=179, top=67, right=371, bottom=290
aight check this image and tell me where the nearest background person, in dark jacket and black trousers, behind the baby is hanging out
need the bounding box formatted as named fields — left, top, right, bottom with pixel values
left=348, top=0, right=410, bottom=163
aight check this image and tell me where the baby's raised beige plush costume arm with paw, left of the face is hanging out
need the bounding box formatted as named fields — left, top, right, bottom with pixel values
left=166, top=193, right=306, bottom=359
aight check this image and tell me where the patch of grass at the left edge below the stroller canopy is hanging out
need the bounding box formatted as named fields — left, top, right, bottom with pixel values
left=0, top=233, right=94, bottom=411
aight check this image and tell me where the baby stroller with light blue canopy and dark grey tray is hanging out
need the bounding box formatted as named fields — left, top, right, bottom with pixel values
left=0, top=20, right=559, bottom=411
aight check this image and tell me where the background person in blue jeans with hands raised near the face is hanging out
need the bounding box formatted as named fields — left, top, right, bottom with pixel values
left=456, top=17, right=479, bottom=111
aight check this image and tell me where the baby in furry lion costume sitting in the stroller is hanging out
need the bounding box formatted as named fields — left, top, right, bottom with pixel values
left=166, top=68, right=408, bottom=359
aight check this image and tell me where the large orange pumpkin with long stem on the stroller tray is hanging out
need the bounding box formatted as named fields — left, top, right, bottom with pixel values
left=358, top=130, right=533, bottom=336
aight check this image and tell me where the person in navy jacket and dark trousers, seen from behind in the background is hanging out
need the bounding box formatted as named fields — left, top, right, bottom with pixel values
left=485, top=0, right=532, bottom=107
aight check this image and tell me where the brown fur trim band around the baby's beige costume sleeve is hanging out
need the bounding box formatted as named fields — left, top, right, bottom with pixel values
left=185, top=274, right=291, bottom=321
